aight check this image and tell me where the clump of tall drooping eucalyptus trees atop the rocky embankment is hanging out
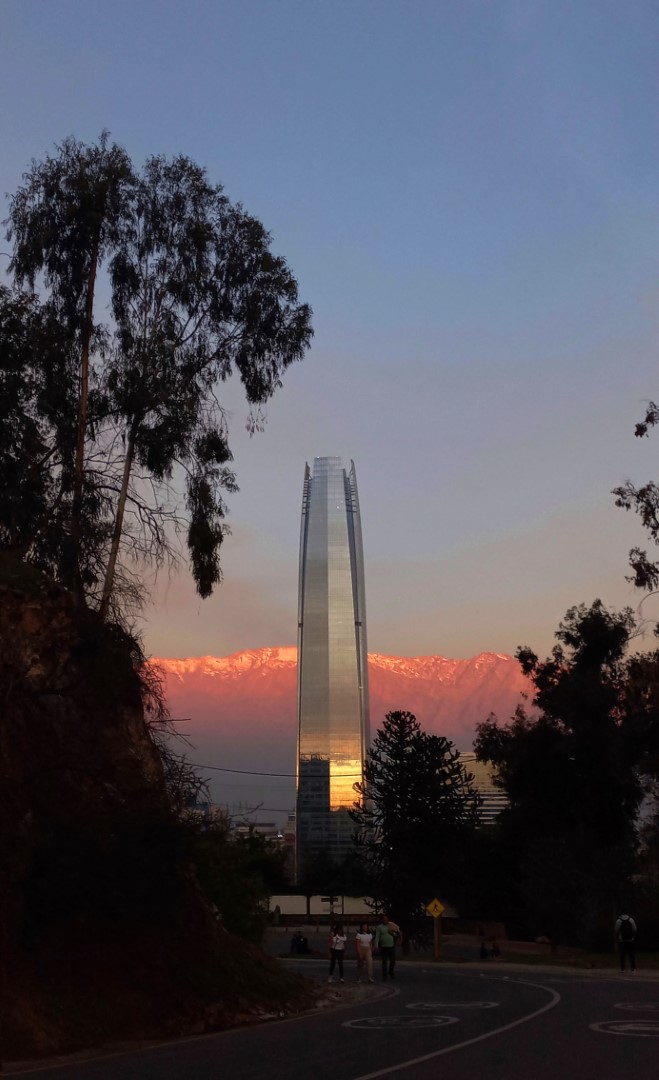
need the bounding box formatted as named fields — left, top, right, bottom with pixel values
left=0, top=135, right=312, bottom=618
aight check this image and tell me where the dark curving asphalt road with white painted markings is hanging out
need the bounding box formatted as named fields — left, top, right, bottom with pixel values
left=8, top=961, right=659, bottom=1080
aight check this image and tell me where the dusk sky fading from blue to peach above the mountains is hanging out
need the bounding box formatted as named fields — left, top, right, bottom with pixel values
left=0, top=0, right=659, bottom=658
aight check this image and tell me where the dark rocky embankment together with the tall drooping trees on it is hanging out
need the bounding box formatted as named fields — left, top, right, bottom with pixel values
left=0, top=133, right=312, bottom=1057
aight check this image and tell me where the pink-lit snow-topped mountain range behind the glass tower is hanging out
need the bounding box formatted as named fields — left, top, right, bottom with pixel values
left=156, top=647, right=528, bottom=806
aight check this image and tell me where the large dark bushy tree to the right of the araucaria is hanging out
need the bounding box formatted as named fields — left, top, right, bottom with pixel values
left=475, top=600, right=656, bottom=943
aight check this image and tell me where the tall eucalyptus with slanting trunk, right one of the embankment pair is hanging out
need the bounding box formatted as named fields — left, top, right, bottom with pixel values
left=100, top=157, right=311, bottom=615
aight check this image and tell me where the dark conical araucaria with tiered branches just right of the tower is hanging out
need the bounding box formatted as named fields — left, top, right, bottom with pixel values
left=351, top=712, right=481, bottom=934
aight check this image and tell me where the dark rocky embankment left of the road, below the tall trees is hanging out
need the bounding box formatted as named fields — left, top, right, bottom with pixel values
left=0, top=556, right=309, bottom=1059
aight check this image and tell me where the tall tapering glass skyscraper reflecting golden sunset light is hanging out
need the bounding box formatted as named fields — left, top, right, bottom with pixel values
left=296, top=458, right=368, bottom=874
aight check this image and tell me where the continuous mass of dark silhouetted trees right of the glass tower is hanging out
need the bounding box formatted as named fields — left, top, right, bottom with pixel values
left=343, top=600, right=659, bottom=946
